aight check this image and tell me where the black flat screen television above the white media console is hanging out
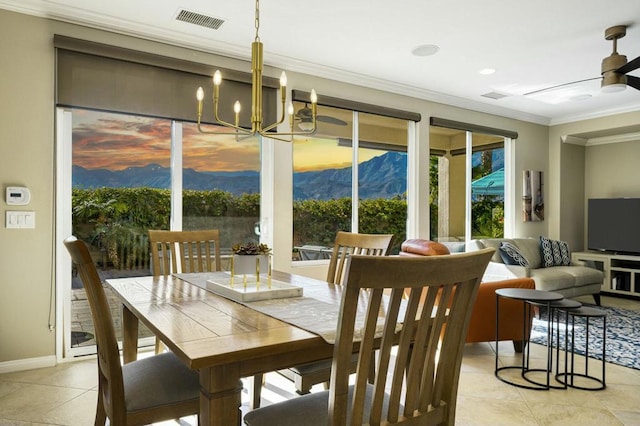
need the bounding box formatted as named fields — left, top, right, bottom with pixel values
left=587, top=198, right=640, bottom=255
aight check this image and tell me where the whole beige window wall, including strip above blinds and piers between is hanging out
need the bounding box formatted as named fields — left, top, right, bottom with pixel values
left=0, top=6, right=584, bottom=371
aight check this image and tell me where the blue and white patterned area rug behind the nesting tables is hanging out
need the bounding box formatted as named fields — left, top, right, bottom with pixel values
left=531, top=304, right=640, bottom=370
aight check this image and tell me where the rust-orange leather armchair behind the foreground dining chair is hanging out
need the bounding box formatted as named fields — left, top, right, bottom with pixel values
left=399, top=239, right=535, bottom=352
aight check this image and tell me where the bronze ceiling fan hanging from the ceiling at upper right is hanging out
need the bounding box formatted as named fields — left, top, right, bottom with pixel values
left=524, top=25, right=640, bottom=96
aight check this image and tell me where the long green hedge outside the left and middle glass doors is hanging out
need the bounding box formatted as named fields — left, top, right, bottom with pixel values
left=72, top=188, right=416, bottom=268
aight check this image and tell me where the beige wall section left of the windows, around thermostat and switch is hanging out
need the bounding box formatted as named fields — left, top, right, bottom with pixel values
left=0, top=12, right=55, bottom=361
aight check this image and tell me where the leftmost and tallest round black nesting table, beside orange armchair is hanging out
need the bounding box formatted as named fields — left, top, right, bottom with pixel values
left=495, top=288, right=564, bottom=390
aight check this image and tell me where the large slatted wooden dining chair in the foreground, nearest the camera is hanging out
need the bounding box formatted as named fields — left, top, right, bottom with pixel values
left=244, top=248, right=494, bottom=426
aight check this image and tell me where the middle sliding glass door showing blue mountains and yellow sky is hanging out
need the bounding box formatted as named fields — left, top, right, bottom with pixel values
left=292, top=104, right=409, bottom=261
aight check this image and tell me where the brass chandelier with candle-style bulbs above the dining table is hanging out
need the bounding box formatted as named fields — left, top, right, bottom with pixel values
left=196, top=0, right=318, bottom=142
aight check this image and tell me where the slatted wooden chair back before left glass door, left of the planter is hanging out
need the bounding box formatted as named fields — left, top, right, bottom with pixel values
left=149, top=229, right=221, bottom=277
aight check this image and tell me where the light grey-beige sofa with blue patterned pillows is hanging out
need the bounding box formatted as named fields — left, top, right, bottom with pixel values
left=466, top=237, right=604, bottom=305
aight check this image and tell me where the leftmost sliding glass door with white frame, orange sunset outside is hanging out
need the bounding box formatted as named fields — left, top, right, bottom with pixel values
left=56, top=109, right=260, bottom=357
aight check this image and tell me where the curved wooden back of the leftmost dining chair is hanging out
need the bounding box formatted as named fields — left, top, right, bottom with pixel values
left=64, top=237, right=127, bottom=425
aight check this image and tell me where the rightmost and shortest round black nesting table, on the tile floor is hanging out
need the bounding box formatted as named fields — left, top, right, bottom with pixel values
left=556, top=306, right=607, bottom=390
